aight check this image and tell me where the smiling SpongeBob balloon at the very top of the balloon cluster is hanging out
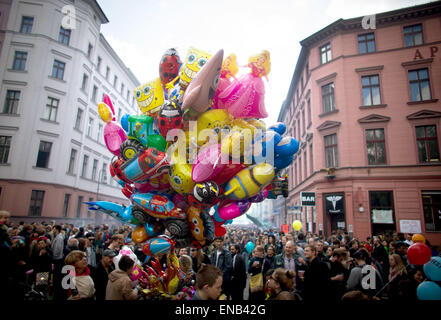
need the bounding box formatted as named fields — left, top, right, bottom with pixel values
left=179, top=47, right=211, bottom=90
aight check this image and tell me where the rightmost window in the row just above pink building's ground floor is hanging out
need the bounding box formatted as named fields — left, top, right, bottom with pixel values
left=416, top=126, right=440, bottom=163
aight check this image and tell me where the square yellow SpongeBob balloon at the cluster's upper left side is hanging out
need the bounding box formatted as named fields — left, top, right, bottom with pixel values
left=134, top=78, right=164, bottom=117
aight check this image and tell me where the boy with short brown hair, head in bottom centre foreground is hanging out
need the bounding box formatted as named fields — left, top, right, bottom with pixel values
left=191, top=264, right=223, bottom=300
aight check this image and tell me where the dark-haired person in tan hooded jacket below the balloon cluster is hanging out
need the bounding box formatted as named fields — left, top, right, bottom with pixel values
left=106, top=256, right=139, bottom=300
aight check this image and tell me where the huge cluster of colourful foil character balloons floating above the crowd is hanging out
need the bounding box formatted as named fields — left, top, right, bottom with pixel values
left=88, top=47, right=299, bottom=252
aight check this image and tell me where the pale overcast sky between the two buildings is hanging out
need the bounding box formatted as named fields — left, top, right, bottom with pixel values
left=98, top=0, right=430, bottom=225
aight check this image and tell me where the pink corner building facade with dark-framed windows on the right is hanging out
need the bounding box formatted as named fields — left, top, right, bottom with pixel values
left=279, top=2, right=441, bottom=245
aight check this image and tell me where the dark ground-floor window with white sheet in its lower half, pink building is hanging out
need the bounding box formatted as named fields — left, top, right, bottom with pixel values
left=369, top=191, right=395, bottom=234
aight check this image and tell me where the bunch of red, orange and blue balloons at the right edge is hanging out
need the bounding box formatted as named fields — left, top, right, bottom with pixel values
left=407, top=234, right=441, bottom=300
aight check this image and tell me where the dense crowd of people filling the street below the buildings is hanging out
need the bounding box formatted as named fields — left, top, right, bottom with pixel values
left=0, top=211, right=439, bottom=301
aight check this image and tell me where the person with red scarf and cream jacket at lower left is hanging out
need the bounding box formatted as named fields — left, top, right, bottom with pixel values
left=64, top=250, right=95, bottom=300
